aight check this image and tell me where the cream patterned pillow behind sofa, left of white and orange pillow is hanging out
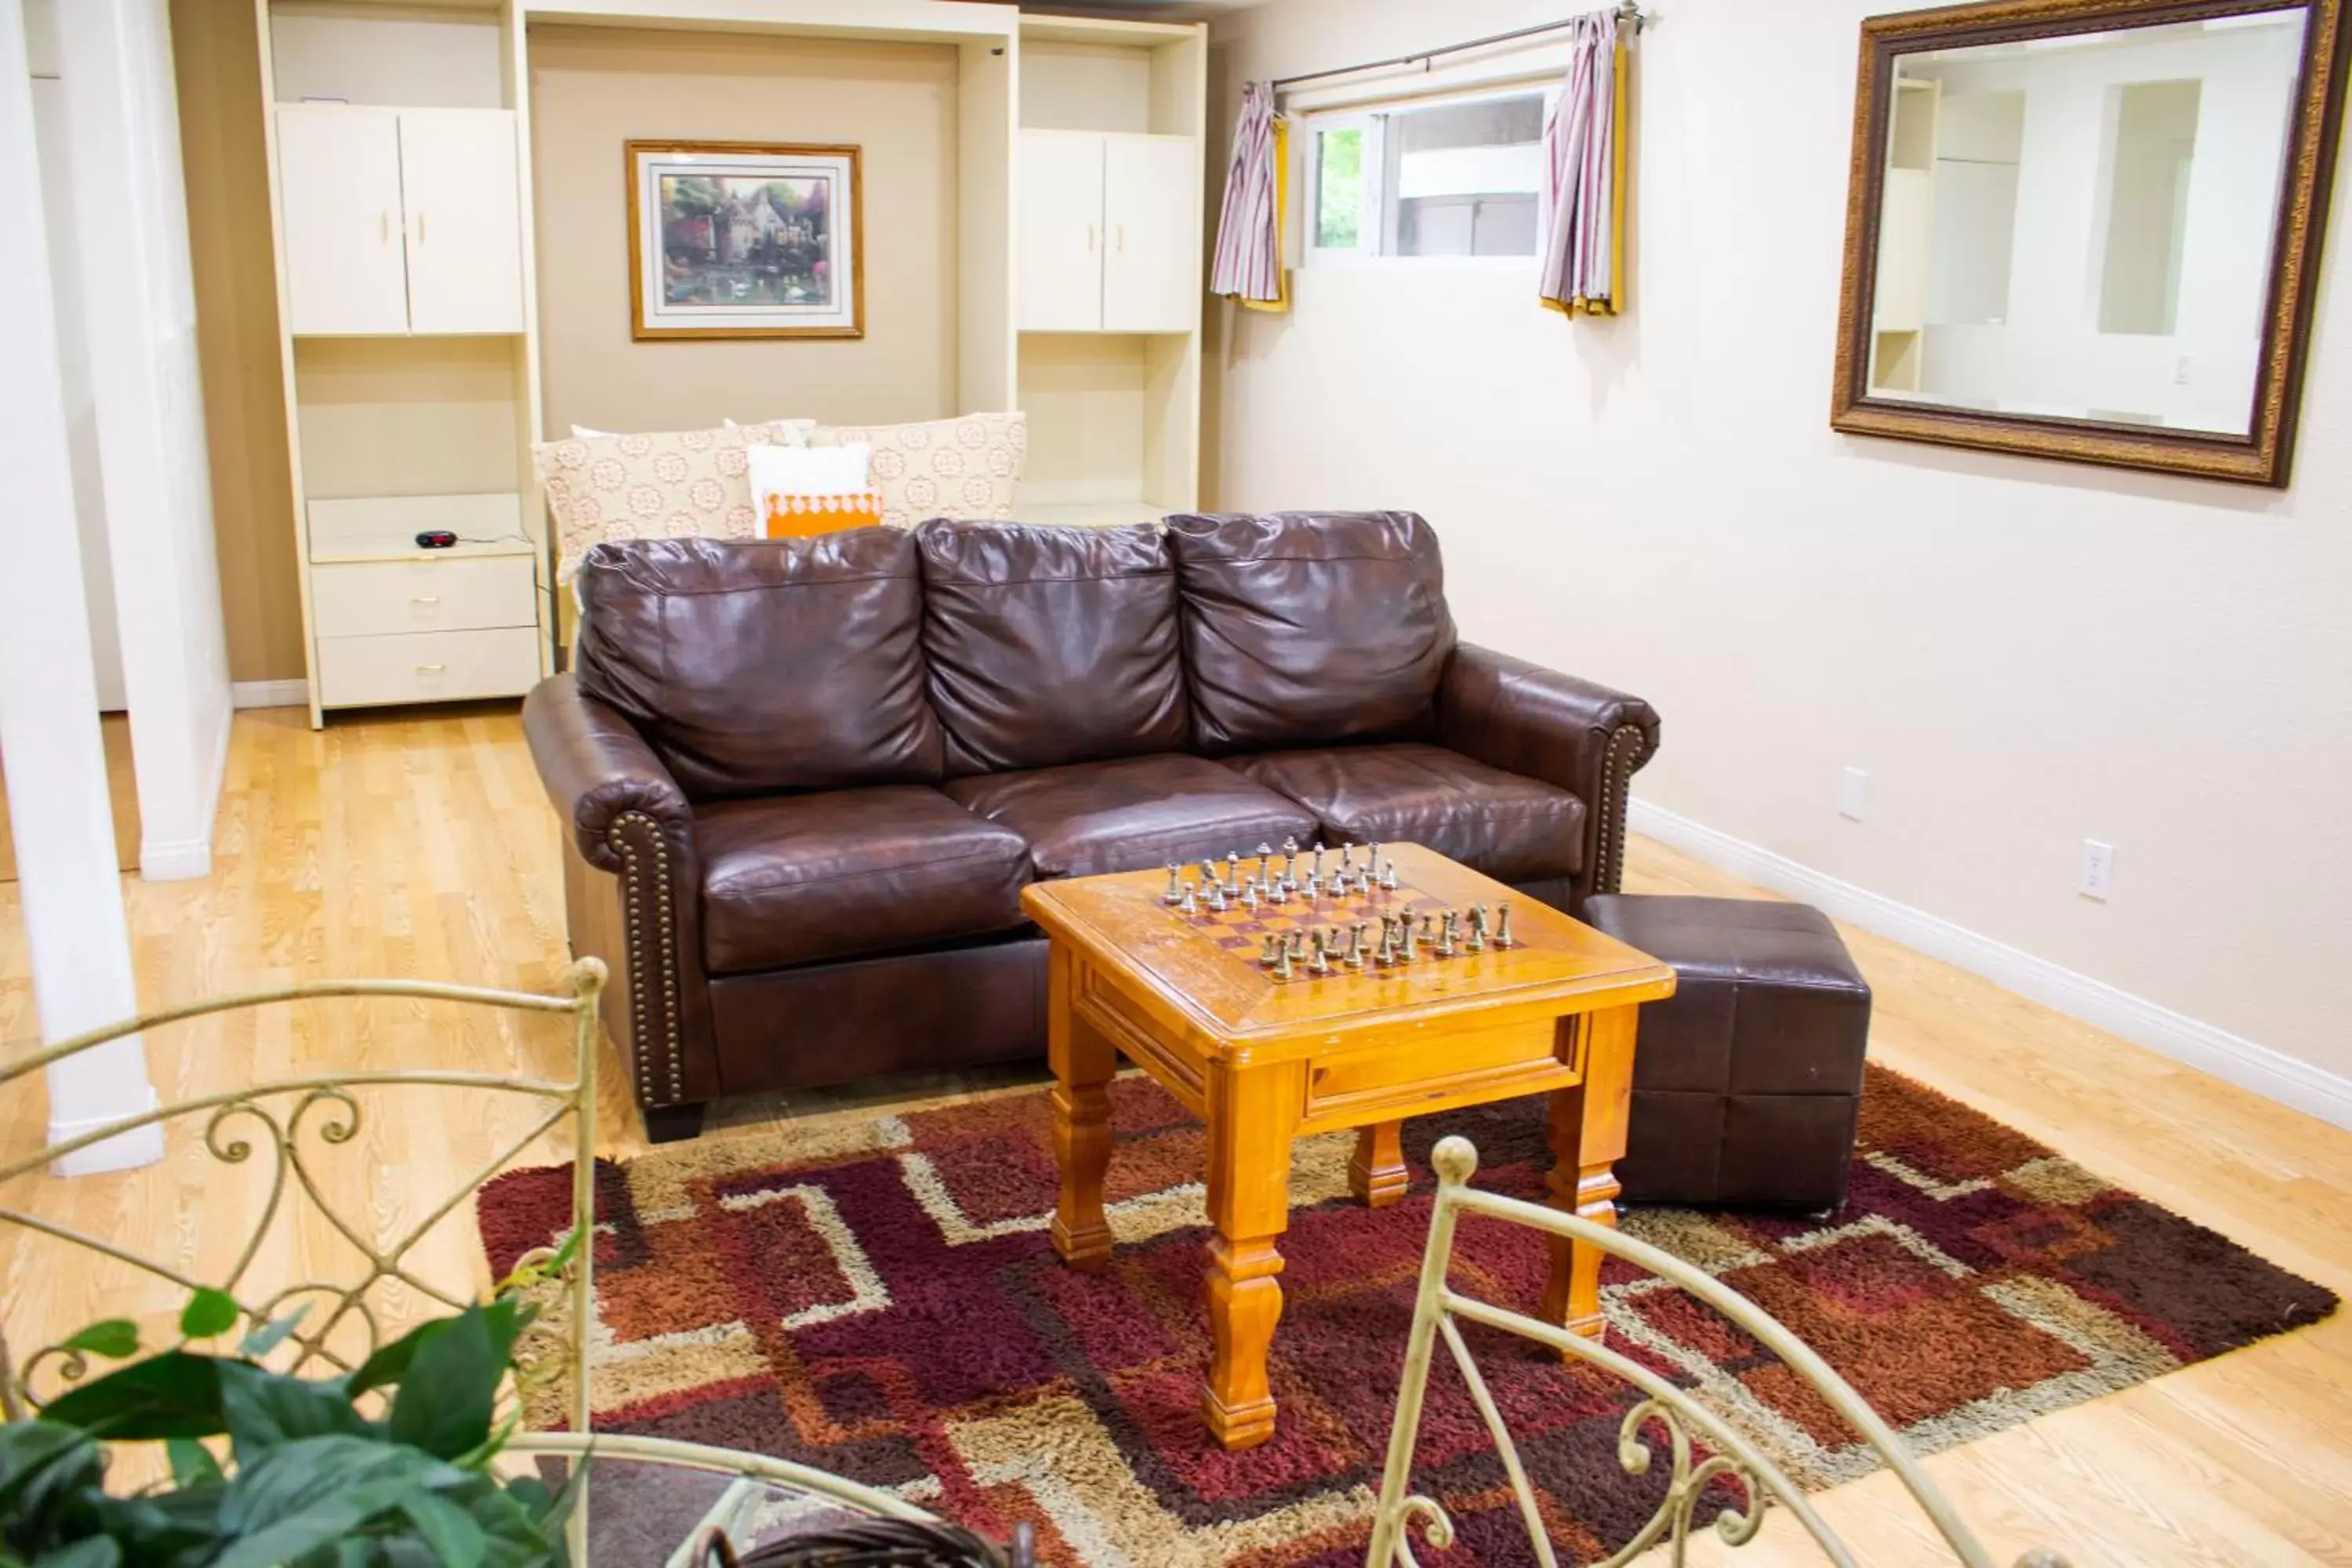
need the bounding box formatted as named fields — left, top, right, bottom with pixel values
left=532, top=419, right=816, bottom=583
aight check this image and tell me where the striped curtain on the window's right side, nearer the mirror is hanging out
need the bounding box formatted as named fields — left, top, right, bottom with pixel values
left=1536, top=12, right=1625, bottom=315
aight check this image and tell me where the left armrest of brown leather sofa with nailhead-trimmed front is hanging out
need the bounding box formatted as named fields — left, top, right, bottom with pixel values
left=522, top=675, right=717, bottom=1112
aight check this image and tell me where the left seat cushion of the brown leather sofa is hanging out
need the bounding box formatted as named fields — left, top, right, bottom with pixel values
left=694, top=785, right=1030, bottom=975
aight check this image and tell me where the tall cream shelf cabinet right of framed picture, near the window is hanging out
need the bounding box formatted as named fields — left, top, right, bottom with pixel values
left=1014, top=14, right=1209, bottom=524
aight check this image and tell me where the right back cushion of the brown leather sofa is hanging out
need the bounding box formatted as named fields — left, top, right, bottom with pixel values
left=1167, top=513, right=1454, bottom=755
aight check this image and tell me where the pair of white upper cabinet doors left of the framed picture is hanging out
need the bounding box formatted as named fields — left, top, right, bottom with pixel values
left=278, top=103, right=522, bottom=336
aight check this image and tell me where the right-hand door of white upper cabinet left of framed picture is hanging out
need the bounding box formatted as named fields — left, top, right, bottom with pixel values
left=400, top=108, right=522, bottom=332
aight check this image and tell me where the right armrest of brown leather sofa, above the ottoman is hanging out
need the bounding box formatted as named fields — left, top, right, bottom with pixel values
left=1437, top=642, right=1658, bottom=914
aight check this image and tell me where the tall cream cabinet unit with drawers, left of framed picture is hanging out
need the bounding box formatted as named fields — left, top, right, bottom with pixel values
left=256, top=0, right=553, bottom=724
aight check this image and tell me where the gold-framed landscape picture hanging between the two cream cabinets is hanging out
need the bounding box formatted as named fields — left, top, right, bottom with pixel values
left=628, top=141, right=866, bottom=341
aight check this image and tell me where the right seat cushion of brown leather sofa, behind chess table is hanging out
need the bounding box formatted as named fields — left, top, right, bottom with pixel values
left=1232, top=743, right=1585, bottom=881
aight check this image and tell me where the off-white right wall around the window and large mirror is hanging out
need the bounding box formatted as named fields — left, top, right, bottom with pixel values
left=1209, top=0, right=2352, bottom=1116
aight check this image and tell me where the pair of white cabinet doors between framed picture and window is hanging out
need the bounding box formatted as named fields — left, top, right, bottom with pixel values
left=1016, top=129, right=1200, bottom=332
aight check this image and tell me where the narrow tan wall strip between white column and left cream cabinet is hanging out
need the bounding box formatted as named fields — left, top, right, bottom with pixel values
left=172, top=0, right=303, bottom=682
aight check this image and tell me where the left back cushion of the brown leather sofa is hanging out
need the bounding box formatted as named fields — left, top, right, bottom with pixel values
left=574, top=529, right=943, bottom=799
